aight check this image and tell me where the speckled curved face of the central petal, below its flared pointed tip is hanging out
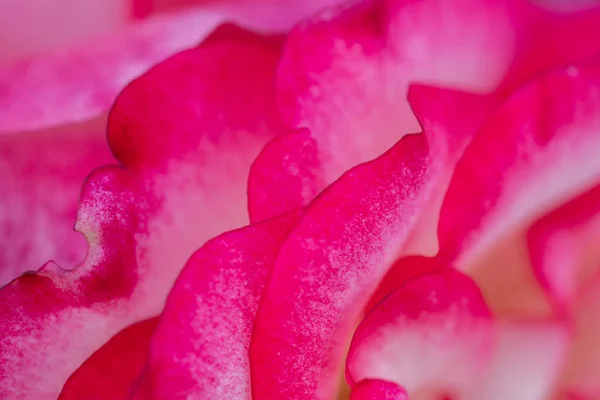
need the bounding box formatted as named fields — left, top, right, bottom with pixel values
left=250, top=135, right=428, bottom=399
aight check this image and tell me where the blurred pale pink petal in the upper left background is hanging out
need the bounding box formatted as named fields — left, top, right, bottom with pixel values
left=0, top=10, right=220, bottom=133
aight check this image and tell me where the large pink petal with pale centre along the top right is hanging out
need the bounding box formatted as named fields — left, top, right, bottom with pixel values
left=250, top=0, right=600, bottom=216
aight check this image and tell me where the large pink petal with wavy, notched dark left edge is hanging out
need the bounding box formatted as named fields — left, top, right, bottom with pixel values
left=0, top=26, right=281, bottom=400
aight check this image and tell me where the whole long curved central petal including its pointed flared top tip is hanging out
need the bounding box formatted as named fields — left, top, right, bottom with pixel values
left=250, top=86, right=493, bottom=399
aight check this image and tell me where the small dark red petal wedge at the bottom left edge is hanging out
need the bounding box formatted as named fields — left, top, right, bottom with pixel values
left=58, top=318, right=158, bottom=400
